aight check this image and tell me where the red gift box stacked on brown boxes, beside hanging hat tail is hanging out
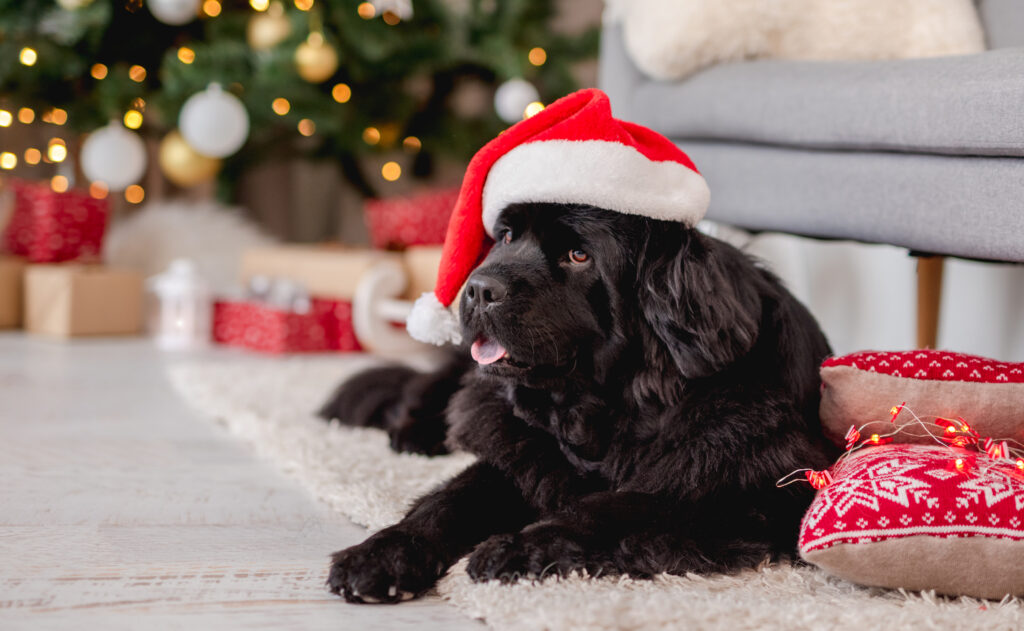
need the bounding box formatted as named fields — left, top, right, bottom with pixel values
left=365, top=188, right=459, bottom=250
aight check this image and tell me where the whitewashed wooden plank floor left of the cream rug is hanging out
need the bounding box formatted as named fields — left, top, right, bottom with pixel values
left=0, top=333, right=482, bottom=631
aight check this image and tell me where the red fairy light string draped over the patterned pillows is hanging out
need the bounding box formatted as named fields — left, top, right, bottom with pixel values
left=776, top=402, right=1024, bottom=491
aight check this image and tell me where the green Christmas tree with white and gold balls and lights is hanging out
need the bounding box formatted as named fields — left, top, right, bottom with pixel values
left=0, top=0, right=597, bottom=196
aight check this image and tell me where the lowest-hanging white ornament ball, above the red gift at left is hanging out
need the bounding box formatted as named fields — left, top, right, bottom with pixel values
left=81, top=123, right=146, bottom=191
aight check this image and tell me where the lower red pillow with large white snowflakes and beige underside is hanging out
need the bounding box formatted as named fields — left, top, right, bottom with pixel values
left=800, top=445, right=1024, bottom=599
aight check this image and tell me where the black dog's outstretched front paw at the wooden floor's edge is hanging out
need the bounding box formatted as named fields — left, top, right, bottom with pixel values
left=327, top=529, right=447, bottom=603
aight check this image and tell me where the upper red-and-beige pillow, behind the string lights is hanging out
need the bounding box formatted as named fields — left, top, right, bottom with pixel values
left=821, top=350, right=1024, bottom=446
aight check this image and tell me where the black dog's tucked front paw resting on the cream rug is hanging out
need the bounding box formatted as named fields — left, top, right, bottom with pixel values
left=466, top=527, right=596, bottom=583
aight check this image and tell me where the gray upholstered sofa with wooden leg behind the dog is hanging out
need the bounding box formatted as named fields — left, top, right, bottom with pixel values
left=599, top=0, right=1024, bottom=346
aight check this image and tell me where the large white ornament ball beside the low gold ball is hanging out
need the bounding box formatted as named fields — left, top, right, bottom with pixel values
left=178, top=83, right=249, bottom=158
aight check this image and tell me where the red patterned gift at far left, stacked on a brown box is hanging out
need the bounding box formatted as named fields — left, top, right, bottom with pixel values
left=3, top=180, right=110, bottom=263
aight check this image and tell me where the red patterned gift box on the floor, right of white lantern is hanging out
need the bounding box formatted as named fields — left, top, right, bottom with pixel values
left=213, top=298, right=361, bottom=353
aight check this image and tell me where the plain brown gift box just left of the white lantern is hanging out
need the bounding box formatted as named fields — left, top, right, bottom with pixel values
left=25, top=263, right=142, bottom=337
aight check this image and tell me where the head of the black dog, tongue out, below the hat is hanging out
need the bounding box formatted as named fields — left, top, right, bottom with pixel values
left=461, top=204, right=761, bottom=387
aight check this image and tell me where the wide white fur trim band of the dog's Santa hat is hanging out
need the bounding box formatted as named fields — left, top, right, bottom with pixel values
left=483, top=140, right=711, bottom=237
